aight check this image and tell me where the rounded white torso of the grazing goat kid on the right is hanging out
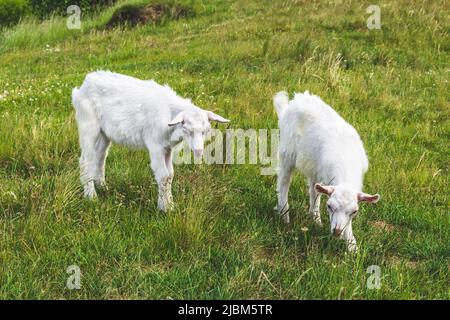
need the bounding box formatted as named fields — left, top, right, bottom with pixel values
left=280, top=92, right=368, bottom=181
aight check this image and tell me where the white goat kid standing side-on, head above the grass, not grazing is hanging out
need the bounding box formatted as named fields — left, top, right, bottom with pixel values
left=72, top=71, right=229, bottom=211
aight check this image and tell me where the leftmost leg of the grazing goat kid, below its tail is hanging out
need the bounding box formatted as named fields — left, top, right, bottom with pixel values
left=277, top=159, right=295, bottom=223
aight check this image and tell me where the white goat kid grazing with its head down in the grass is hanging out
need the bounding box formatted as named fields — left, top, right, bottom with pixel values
left=273, top=91, right=380, bottom=251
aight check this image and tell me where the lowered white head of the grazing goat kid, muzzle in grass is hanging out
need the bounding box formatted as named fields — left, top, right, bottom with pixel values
left=314, top=183, right=380, bottom=237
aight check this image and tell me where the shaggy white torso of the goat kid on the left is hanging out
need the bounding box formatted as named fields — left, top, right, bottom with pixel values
left=72, top=71, right=188, bottom=147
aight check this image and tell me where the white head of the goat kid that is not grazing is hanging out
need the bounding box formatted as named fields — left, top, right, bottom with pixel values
left=169, top=109, right=230, bottom=158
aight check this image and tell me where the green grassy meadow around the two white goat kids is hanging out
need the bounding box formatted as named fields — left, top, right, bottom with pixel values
left=0, top=0, right=450, bottom=299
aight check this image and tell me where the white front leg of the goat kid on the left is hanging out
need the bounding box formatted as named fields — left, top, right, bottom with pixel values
left=149, top=146, right=173, bottom=212
